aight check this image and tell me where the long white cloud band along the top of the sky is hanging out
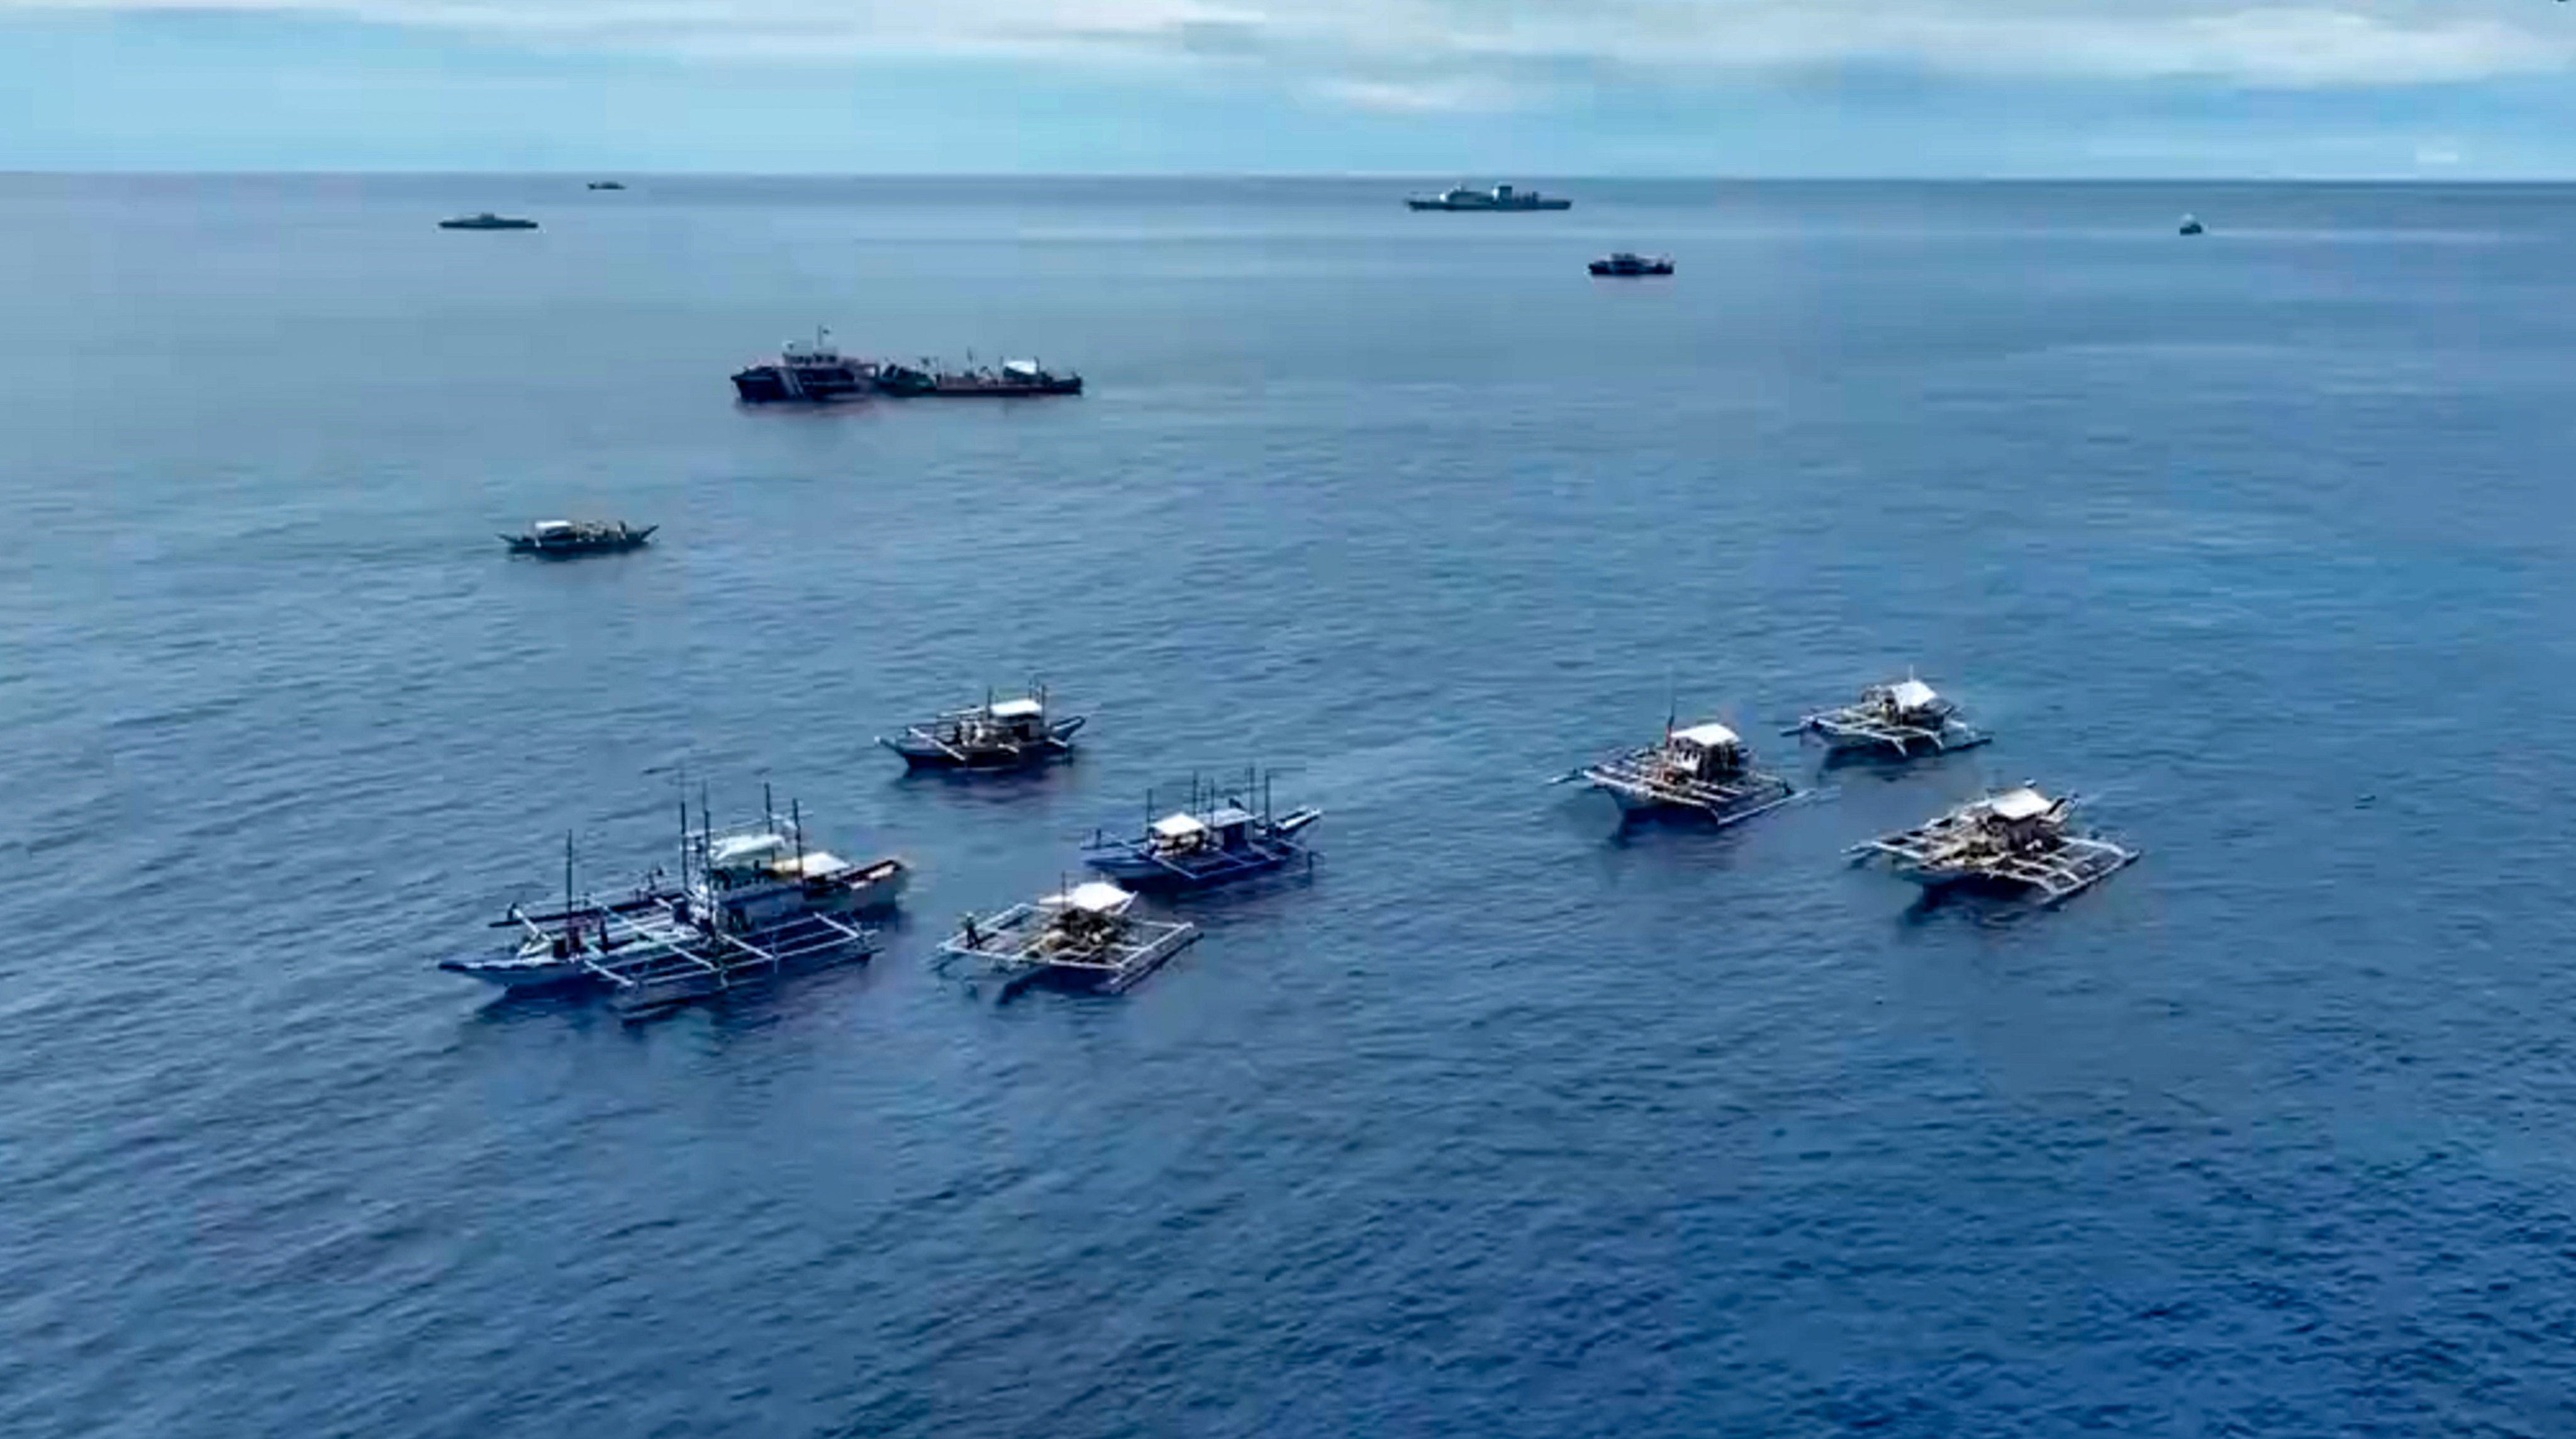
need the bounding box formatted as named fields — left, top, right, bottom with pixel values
left=20, top=0, right=2576, bottom=91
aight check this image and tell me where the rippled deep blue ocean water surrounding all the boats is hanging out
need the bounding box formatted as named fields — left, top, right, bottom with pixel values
left=0, top=177, right=2576, bottom=1439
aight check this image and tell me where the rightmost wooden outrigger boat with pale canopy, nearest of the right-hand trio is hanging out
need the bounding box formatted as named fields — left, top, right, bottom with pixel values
left=1849, top=785, right=2138, bottom=906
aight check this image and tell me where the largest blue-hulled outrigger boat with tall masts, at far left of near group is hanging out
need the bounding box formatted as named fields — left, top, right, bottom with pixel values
left=438, top=787, right=910, bottom=1017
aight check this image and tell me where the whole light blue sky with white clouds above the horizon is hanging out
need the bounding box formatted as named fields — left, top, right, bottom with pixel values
left=0, top=0, right=2576, bottom=181
